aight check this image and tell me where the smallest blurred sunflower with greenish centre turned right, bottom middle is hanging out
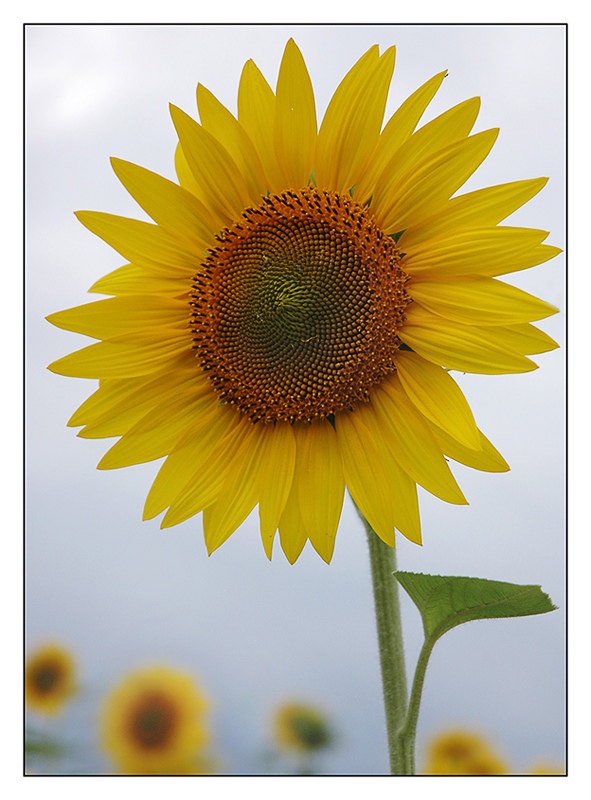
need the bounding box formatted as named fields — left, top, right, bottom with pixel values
left=273, top=703, right=333, bottom=753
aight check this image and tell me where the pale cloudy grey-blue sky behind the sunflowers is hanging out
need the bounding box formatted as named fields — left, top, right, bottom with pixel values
left=26, top=25, right=565, bottom=774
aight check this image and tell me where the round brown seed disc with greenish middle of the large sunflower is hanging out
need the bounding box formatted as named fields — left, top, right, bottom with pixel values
left=191, top=188, right=410, bottom=422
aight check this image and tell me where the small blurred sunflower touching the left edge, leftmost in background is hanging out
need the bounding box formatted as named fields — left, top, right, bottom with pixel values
left=25, top=644, right=76, bottom=715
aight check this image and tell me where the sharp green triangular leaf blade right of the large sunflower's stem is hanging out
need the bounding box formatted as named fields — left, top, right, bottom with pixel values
left=394, top=572, right=556, bottom=640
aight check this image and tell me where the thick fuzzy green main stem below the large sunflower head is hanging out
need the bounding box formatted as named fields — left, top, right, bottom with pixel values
left=360, top=514, right=414, bottom=775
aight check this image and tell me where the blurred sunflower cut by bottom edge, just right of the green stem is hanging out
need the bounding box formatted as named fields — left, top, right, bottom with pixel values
left=423, top=730, right=509, bottom=775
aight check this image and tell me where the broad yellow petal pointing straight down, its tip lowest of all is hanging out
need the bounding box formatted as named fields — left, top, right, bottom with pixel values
left=294, top=420, right=345, bottom=564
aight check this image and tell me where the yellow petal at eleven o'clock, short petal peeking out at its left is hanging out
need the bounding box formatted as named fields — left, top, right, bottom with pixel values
left=170, top=106, right=250, bottom=227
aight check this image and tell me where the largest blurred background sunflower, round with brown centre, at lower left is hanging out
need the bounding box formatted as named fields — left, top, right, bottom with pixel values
left=100, top=666, right=209, bottom=775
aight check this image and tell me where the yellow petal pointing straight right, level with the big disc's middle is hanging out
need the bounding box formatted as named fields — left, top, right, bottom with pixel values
left=406, top=278, right=558, bottom=325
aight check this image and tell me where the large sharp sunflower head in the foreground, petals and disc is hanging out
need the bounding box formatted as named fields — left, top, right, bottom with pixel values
left=48, top=40, right=560, bottom=563
